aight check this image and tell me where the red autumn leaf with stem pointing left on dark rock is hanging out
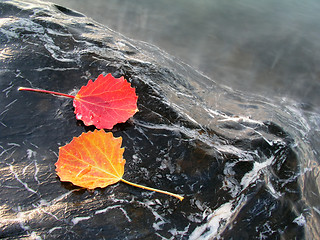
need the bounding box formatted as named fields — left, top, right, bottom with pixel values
left=19, top=73, right=138, bottom=129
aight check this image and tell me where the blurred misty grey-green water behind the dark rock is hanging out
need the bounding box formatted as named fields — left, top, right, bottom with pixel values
left=48, top=0, right=320, bottom=107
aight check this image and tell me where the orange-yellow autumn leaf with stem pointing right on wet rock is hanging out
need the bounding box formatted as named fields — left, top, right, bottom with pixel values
left=55, top=130, right=183, bottom=201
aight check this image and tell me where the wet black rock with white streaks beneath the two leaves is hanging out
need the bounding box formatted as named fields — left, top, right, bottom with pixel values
left=0, top=0, right=319, bottom=239
